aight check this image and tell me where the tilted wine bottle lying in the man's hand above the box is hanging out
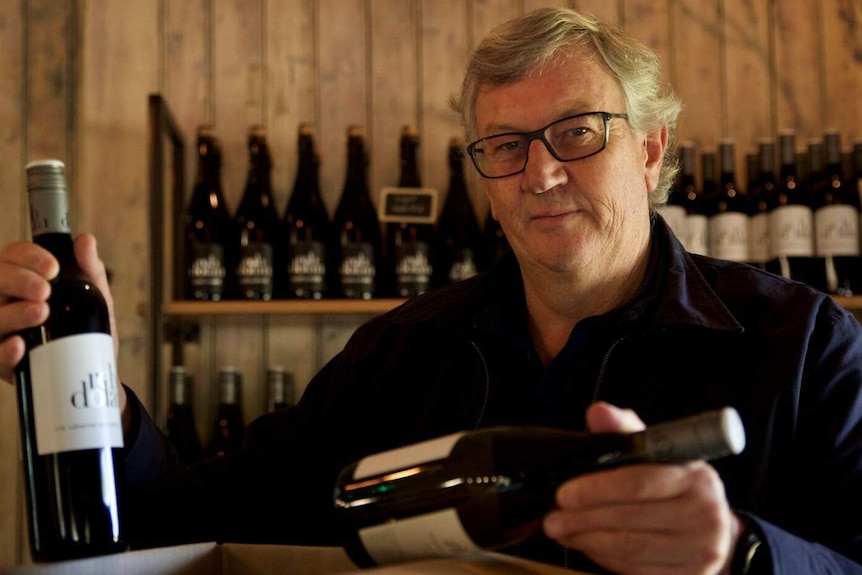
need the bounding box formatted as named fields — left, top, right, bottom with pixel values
left=333, top=408, right=745, bottom=566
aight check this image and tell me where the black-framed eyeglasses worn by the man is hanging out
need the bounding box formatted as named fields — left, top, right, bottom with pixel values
left=467, top=112, right=629, bottom=178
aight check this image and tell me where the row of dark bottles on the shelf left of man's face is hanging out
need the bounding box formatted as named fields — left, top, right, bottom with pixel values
left=184, top=124, right=507, bottom=301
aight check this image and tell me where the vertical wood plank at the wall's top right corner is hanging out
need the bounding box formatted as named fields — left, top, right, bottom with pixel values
left=822, top=0, right=862, bottom=144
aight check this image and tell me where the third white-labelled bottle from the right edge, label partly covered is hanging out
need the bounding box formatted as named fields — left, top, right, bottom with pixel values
left=748, top=139, right=776, bottom=269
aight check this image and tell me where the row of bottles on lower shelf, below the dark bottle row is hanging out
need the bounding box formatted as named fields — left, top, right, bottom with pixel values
left=165, top=365, right=294, bottom=464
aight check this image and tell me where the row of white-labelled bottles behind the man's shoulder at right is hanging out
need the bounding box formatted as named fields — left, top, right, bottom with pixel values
left=660, top=131, right=862, bottom=296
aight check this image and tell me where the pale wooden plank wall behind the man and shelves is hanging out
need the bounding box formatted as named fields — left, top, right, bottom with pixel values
left=0, top=0, right=862, bottom=564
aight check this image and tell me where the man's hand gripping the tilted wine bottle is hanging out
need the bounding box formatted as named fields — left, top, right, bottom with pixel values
left=544, top=403, right=741, bottom=575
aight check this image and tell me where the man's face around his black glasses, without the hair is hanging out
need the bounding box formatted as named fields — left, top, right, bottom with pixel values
left=476, top=53, right=664, bottom=279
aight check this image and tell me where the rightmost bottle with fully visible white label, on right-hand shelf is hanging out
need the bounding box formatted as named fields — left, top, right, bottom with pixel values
left=809, top=131, right=862, bottom=296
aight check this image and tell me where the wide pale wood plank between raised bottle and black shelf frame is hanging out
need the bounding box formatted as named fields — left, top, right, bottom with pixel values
left=77, top=0, right=159, bottom=403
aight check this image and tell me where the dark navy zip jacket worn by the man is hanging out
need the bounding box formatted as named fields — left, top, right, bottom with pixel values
left=126, top=218, right=862, bottom=575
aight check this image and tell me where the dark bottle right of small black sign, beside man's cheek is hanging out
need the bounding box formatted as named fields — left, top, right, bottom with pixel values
left=434, top=138, right=481, bottom=286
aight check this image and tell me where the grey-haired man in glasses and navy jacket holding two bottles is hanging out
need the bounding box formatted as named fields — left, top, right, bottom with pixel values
left=0, top=9, right=862, bottom=575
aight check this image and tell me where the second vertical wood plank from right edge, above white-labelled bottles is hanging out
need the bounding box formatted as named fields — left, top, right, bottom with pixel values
left=773, top=2, right=823, bottom=138
